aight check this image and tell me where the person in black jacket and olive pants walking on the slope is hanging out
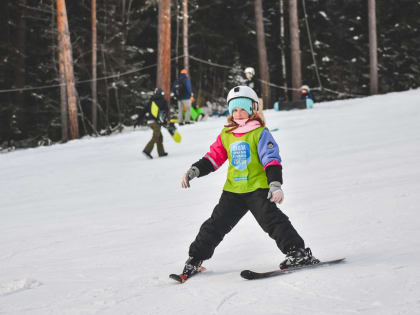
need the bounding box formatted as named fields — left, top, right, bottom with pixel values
left=143, top=88, right=169, bottom=159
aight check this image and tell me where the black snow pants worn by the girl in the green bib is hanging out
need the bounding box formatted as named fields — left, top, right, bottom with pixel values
left=189, top=189, right=305, bottom=260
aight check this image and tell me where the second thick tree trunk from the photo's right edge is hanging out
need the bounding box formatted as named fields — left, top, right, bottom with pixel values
left=289, top=0, right=302, bottom=101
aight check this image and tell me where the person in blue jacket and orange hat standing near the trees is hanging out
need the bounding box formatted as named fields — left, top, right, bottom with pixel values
left=172, top=69, right=192, bottom=125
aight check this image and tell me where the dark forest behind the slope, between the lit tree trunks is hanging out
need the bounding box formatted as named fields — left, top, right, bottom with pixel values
left=0, top=0, right=420, bottom=147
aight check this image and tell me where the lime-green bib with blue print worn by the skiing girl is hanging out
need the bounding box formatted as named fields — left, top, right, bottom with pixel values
left=221, top=127, right=269, bottom=193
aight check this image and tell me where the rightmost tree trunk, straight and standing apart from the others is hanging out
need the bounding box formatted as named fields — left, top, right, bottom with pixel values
left=368, top=0, right=378, bottom=95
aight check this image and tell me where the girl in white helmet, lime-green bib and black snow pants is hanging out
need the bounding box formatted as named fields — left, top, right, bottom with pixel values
left=177, top=86, right=319, bottom=279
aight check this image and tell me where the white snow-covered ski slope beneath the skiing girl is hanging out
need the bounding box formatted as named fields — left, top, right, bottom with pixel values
left=0, top=90, right=420, bottom=315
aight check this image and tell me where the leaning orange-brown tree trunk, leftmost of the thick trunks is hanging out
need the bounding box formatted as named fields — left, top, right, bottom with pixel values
left=57, top=0, right=79, bottom=139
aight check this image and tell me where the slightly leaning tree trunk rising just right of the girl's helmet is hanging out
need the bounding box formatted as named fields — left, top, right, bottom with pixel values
left=254, top=0, right=271, bottom=107
